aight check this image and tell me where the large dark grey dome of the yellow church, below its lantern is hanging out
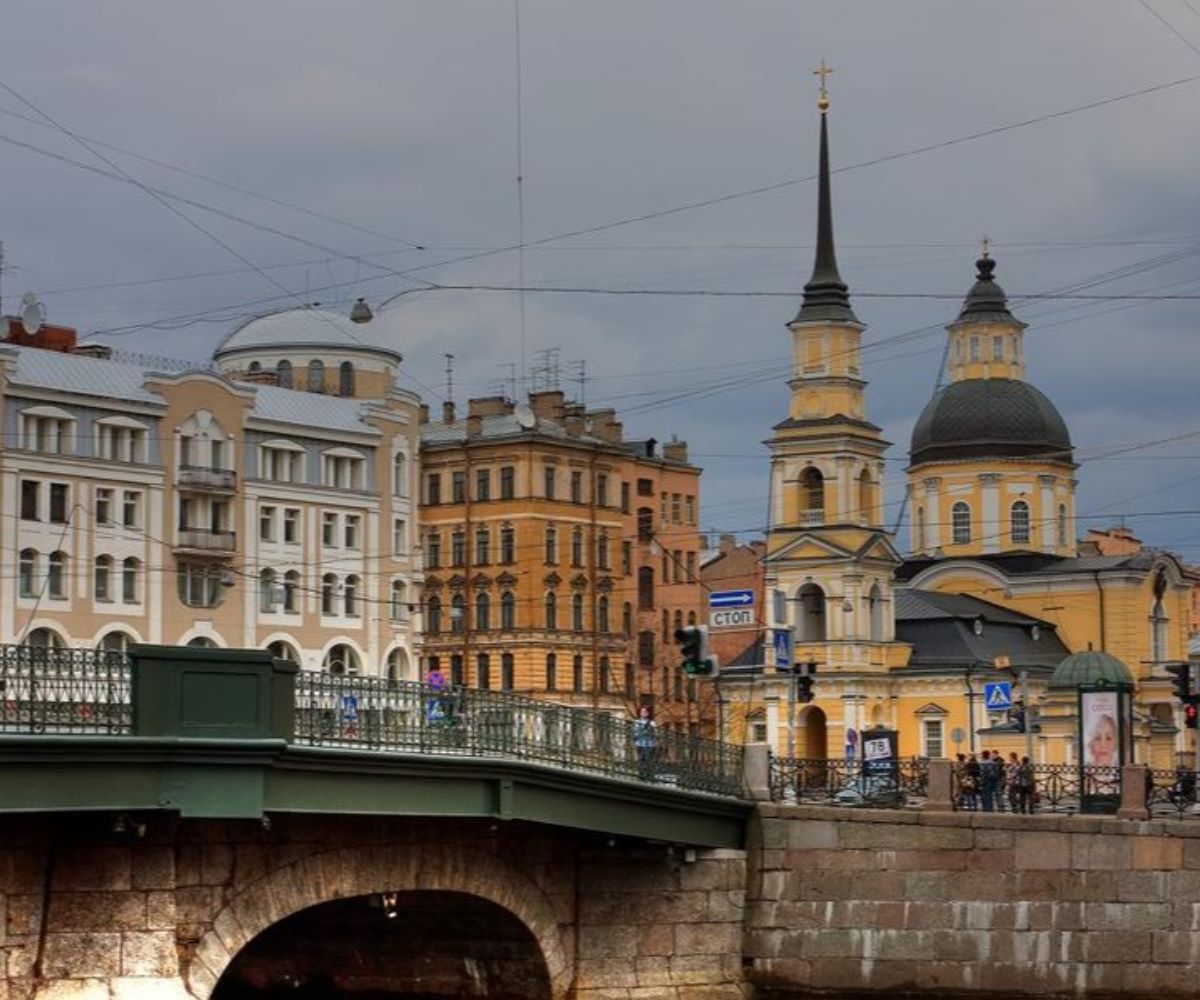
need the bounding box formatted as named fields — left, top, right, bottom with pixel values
left=908, top=378, right=1072, bottom=465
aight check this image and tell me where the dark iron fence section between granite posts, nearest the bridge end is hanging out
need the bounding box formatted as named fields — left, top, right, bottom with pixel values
left=770, top=754, right=929, bottom=808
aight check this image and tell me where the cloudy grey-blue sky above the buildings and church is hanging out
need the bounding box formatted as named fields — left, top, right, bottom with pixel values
left=0, top=0, right=1200, bottom=563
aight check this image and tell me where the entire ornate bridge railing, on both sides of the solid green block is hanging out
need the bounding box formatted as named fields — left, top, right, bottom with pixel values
left=0, top=646, right=743, bottom=797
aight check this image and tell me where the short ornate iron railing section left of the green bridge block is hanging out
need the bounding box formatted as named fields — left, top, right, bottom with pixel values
left=0, top=646, right=132, bottom=735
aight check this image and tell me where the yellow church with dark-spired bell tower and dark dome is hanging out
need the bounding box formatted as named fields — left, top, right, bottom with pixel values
left=722, top=85, right=1196, bottom=767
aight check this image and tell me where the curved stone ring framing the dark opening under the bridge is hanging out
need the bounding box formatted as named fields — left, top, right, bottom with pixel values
left=184, top=844, right=572, bottom=1000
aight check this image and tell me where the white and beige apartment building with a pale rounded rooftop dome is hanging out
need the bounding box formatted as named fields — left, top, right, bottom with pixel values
left=0, top=309, right=422, bottom=679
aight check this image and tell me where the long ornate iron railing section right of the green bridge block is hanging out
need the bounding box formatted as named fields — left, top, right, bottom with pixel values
left=295, top=671, right=742, bottom=796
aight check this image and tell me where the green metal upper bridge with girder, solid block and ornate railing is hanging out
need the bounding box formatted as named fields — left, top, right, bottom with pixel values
left=0, top=646, right=751, bottom=848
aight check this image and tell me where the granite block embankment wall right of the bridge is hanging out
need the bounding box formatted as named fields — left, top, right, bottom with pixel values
left=745, top=804, right=1200, bottom=996
